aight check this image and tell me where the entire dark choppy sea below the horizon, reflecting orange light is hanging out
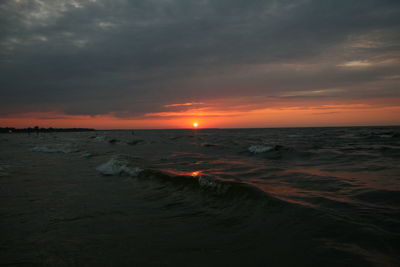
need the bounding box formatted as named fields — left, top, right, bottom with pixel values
left=0, top=127, right=400, bottom=266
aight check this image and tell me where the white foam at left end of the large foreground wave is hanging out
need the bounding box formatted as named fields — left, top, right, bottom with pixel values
left=96, top=155, right=143, bottom=176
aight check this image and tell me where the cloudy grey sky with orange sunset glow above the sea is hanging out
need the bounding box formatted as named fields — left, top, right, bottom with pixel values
left=0, top=0, right=400, bottom=129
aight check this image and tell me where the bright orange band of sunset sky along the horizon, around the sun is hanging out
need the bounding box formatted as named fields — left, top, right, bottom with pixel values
left=0, top=98, right=400, bottom=130
